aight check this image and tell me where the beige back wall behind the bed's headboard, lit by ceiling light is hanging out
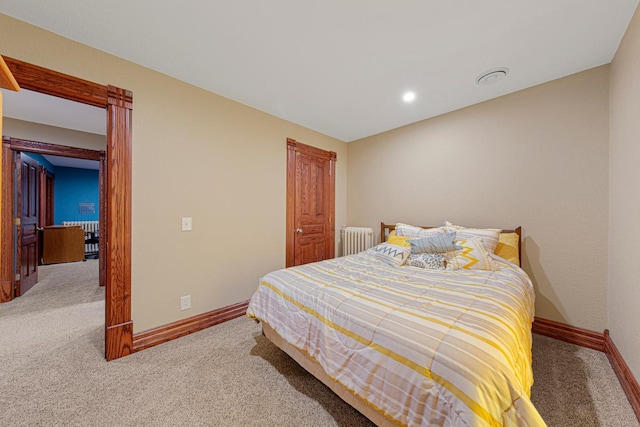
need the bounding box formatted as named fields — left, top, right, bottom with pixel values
left=347, top=66, right=609, bottom=331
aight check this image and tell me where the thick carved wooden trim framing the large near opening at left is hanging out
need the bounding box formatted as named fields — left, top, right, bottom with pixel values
left=0, top=57, right=133, bottom=360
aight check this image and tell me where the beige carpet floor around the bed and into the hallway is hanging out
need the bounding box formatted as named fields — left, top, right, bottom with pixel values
left=0, top=261, right=640, bottom=427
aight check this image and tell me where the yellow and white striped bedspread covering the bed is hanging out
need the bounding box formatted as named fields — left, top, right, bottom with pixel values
left=247, top=250, right=545, bottom=426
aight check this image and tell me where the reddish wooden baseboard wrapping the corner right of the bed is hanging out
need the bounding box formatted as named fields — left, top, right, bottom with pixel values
left=531, top=317, right=640, bottom=421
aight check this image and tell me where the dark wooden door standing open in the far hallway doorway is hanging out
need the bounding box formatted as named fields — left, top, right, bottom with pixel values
left=16, top=153, right=40, bottom=297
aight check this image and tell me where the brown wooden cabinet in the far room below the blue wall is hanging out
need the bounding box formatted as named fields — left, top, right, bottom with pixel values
left=42, top=225, right=84, bottom=264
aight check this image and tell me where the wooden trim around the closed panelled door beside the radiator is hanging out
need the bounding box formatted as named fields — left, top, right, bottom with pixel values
left=285, top=138, right=337, bottom=267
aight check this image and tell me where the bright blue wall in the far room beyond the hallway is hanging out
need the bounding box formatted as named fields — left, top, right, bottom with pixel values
left=53, top=166, right=100, bottom=224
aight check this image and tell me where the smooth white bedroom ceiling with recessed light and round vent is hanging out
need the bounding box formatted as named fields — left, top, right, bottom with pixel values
left=0, top=0, right=638, bottom=141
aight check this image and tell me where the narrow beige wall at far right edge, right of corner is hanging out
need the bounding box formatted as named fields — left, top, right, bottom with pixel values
left=609, top=5, right=640, bottom=379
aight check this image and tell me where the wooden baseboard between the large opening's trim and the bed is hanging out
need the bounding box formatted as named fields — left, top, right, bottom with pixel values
left=133, top=301, right=249, bottom=352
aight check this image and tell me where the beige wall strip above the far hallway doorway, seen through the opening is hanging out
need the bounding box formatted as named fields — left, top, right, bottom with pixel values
left=3, top=117, right=107, bottom=150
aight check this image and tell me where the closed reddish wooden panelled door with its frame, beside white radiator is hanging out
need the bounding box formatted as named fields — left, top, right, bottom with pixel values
left=286, top=139, right=336, bottom=267
